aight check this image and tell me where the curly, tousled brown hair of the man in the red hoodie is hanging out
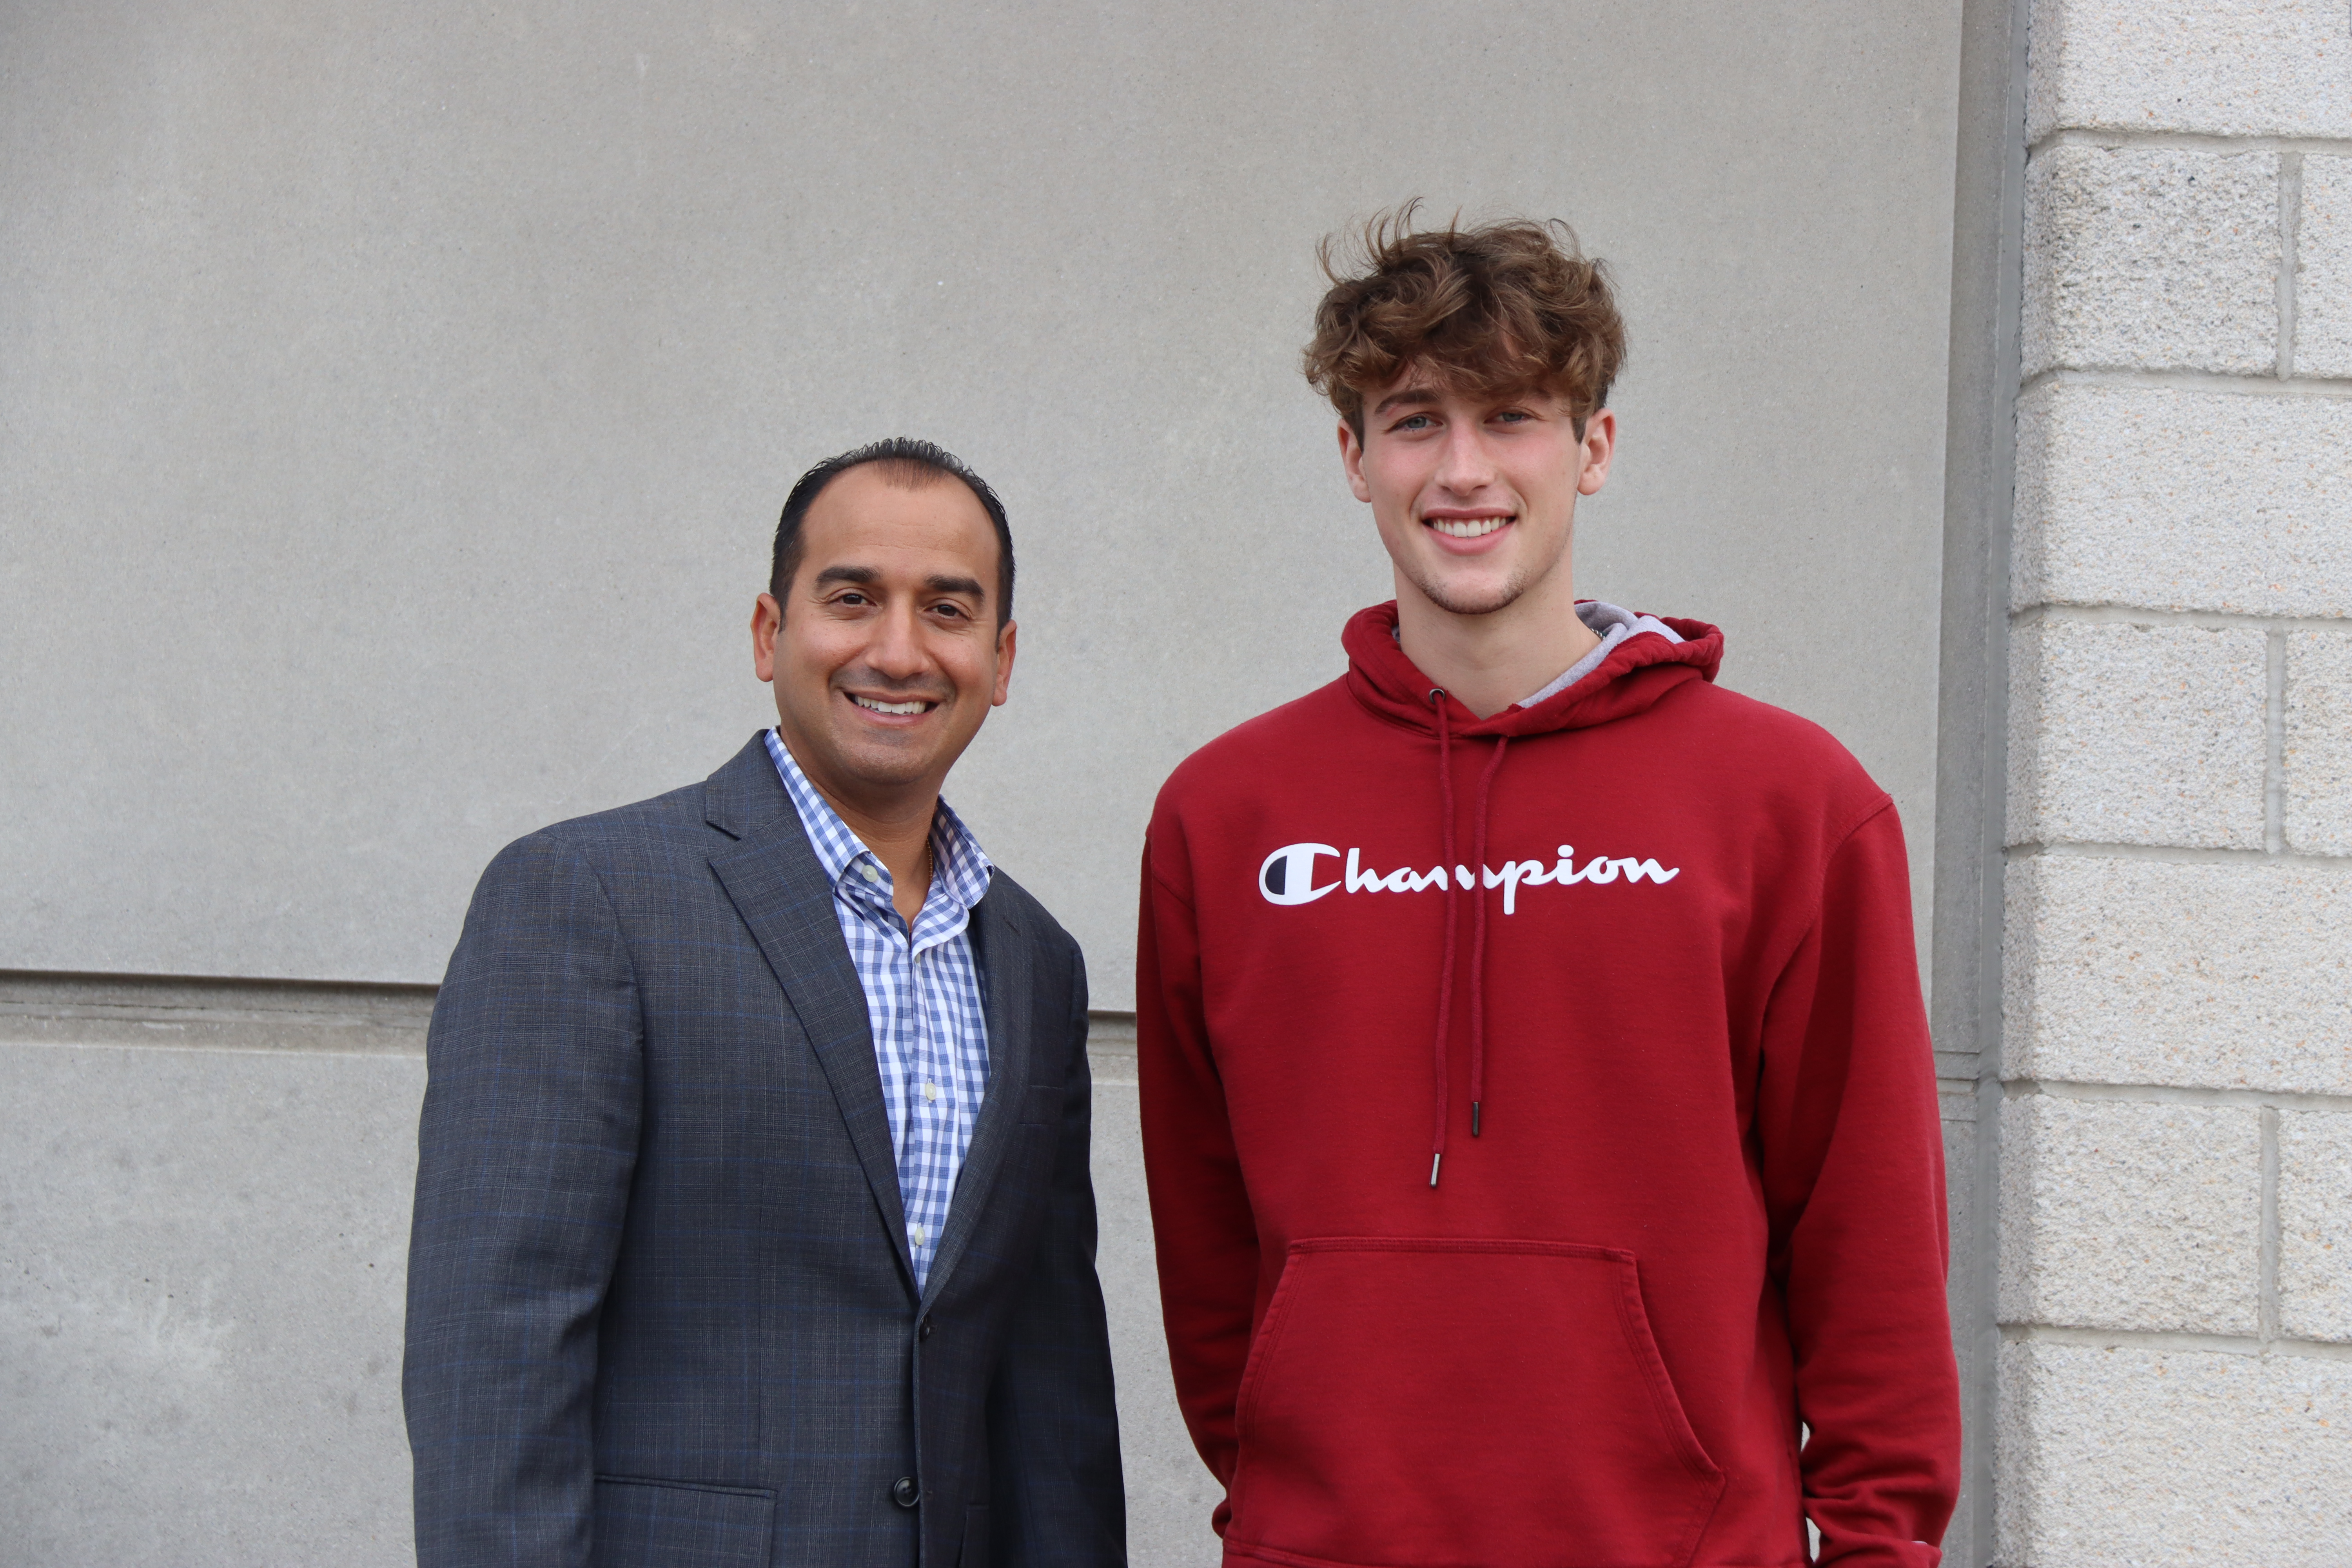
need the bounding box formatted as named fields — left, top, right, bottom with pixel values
left=1303, top=202, right=1625, bottom=439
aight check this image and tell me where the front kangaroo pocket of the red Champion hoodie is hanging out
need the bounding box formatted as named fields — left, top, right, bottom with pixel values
left=1225, top=1239, right=1724, bottom=1568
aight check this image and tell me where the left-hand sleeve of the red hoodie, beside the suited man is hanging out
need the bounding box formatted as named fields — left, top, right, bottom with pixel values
left=1136, top=846, right=1258, bottom=1535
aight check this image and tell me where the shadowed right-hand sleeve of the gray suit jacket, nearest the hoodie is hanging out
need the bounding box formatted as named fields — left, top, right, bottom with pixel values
left=988, top=943, right=1127, bottom=1568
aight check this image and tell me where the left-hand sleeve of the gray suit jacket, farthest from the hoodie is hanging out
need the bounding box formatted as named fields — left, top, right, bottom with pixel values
left=402, top=835, right=642, bottom=1568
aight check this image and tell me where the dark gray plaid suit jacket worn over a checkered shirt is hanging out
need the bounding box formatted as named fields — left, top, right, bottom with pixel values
left=402, top=736, right=1127, bottom=1568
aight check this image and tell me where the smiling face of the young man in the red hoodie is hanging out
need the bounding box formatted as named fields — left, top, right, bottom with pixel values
left=1338, top=367, right=1616, bottom=616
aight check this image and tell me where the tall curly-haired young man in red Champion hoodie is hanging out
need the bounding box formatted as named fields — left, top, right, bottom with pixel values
left=1136, top=212, right=1959, bottom=1568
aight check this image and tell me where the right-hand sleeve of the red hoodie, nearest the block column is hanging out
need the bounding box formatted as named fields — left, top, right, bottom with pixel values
left=1757, top=802, right=1959, bottom=1568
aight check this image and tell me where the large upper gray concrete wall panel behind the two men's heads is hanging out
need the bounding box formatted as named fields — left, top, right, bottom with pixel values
left=0, top=0, right=1962, bottom=1006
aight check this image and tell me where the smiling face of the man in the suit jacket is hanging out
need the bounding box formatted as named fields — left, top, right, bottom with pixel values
left=750, top=465, right=1014, bottom=813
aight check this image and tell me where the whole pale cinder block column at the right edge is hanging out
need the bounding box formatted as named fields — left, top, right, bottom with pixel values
left=1992, top=0, right=2352, bottom=1568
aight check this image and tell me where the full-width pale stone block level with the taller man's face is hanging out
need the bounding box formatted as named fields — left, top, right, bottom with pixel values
left=2013, top=386, right=2352, bottom=616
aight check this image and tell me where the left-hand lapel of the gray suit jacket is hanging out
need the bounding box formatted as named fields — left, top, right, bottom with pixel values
left=703, top=736, right=908, bottom=1290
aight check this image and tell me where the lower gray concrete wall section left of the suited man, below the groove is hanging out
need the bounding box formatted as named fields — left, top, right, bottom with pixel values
left=0, top=1044, right=426, bottom=1568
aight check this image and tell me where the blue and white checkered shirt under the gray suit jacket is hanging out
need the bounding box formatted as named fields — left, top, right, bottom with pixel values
left=767, top=729, right=990, bottom=1290
